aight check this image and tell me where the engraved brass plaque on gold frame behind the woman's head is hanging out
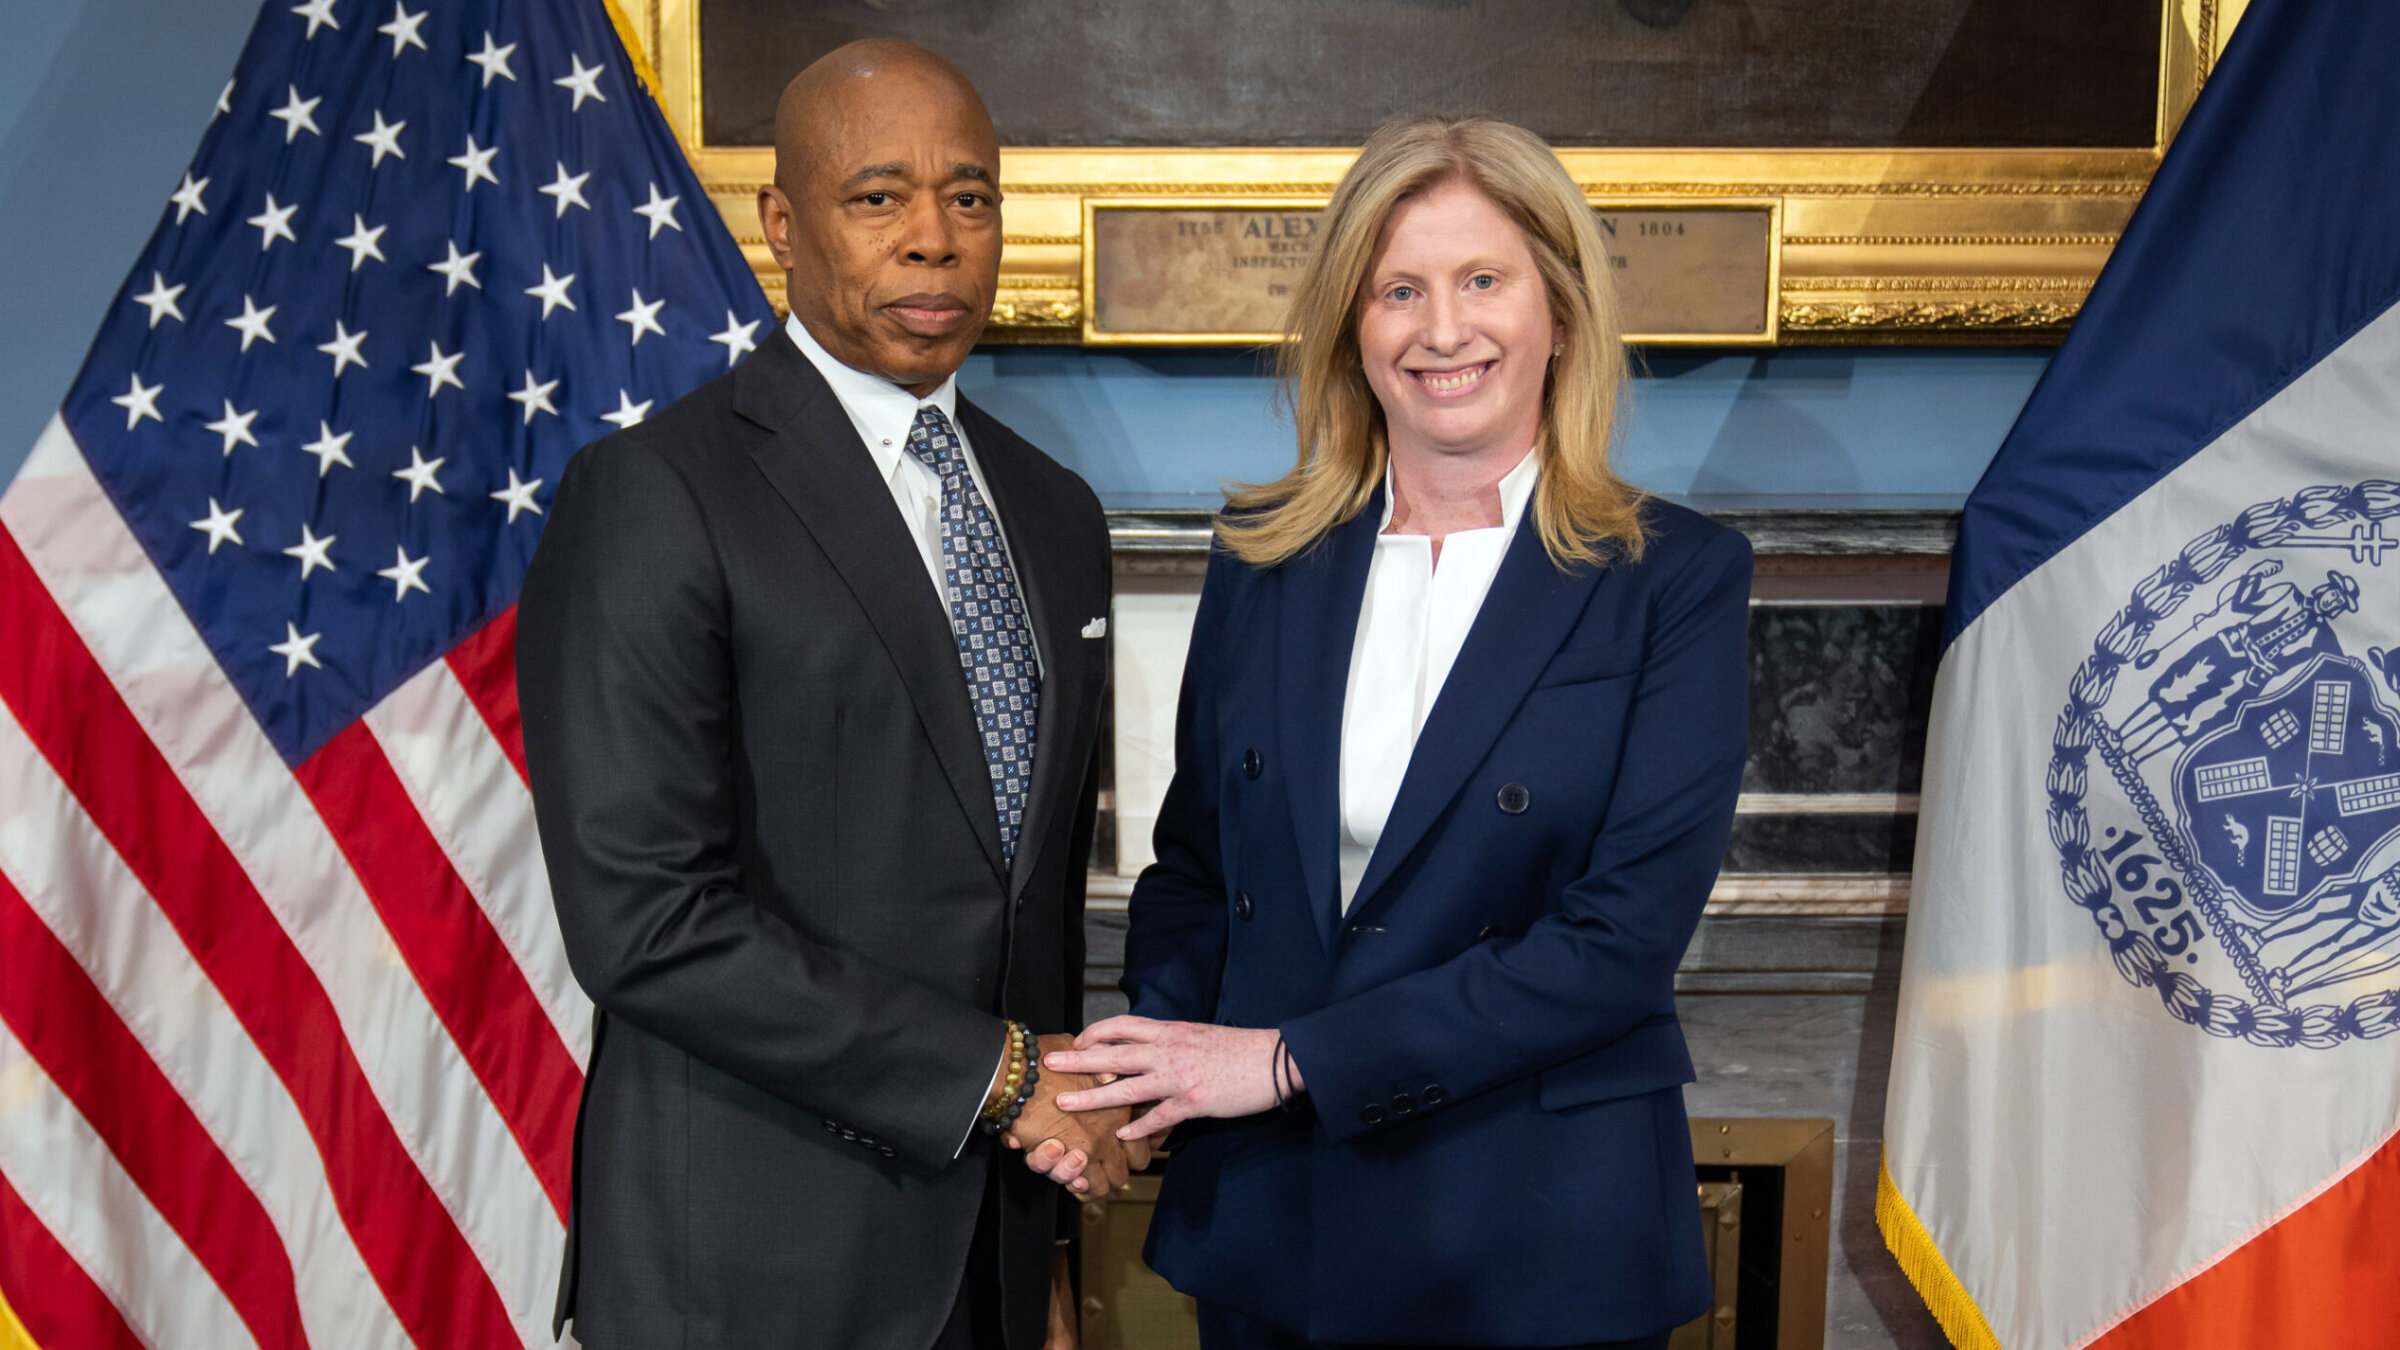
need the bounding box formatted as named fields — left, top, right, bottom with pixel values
left=1082, top=202, right=1781, bottom=346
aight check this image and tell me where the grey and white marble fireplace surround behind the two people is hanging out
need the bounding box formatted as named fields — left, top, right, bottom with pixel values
left=1085, top=497, right=1958, bottom=1350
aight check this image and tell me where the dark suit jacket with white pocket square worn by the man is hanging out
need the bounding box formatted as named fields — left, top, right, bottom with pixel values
left=516, top=334, right=1109, bottom=1350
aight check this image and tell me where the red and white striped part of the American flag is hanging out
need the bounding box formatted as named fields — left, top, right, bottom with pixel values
left=0, top=418, right=590, bottom=1350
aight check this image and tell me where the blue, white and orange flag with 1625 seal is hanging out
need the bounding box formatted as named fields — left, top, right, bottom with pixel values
left=1877, top=0, right=2400, bottom=1350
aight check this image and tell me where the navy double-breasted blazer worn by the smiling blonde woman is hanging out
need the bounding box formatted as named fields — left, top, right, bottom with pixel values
left=1126, top=492, right=1750, bottom=1345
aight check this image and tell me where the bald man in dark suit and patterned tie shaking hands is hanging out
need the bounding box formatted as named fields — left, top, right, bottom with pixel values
left=518, top=43, right=1128, bottom=1350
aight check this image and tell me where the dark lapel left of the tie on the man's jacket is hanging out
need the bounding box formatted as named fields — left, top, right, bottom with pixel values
left=734, top=329, right=1001, bottom=874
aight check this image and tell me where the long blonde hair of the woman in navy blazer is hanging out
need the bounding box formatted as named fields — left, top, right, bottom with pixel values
left=1217, top=118, right=1644, bottom=569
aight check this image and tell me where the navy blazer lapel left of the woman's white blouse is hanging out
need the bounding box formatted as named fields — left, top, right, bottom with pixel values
left=1274, top=488, right=1382, bottom=951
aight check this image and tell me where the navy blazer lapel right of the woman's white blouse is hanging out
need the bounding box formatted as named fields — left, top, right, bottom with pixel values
left=1351, top=512, right=1606, bottom=920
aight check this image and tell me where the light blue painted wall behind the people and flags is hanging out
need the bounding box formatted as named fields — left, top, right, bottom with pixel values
left=0, top=0, right=2050, bottom=504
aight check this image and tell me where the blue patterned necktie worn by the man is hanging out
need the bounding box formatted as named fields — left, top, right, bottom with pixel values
left=907, top=406, right=1042, bottom=865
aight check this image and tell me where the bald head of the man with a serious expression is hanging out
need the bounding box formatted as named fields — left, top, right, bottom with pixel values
left=758, top=65, right=1001, bottom=396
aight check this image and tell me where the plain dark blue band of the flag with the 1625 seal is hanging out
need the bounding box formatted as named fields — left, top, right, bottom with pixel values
left=1944, top=0, right=2400, bottom=644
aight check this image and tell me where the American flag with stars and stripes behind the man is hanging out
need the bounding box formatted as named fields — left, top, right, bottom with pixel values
left=0, top=0, right=773, bottom=1350
